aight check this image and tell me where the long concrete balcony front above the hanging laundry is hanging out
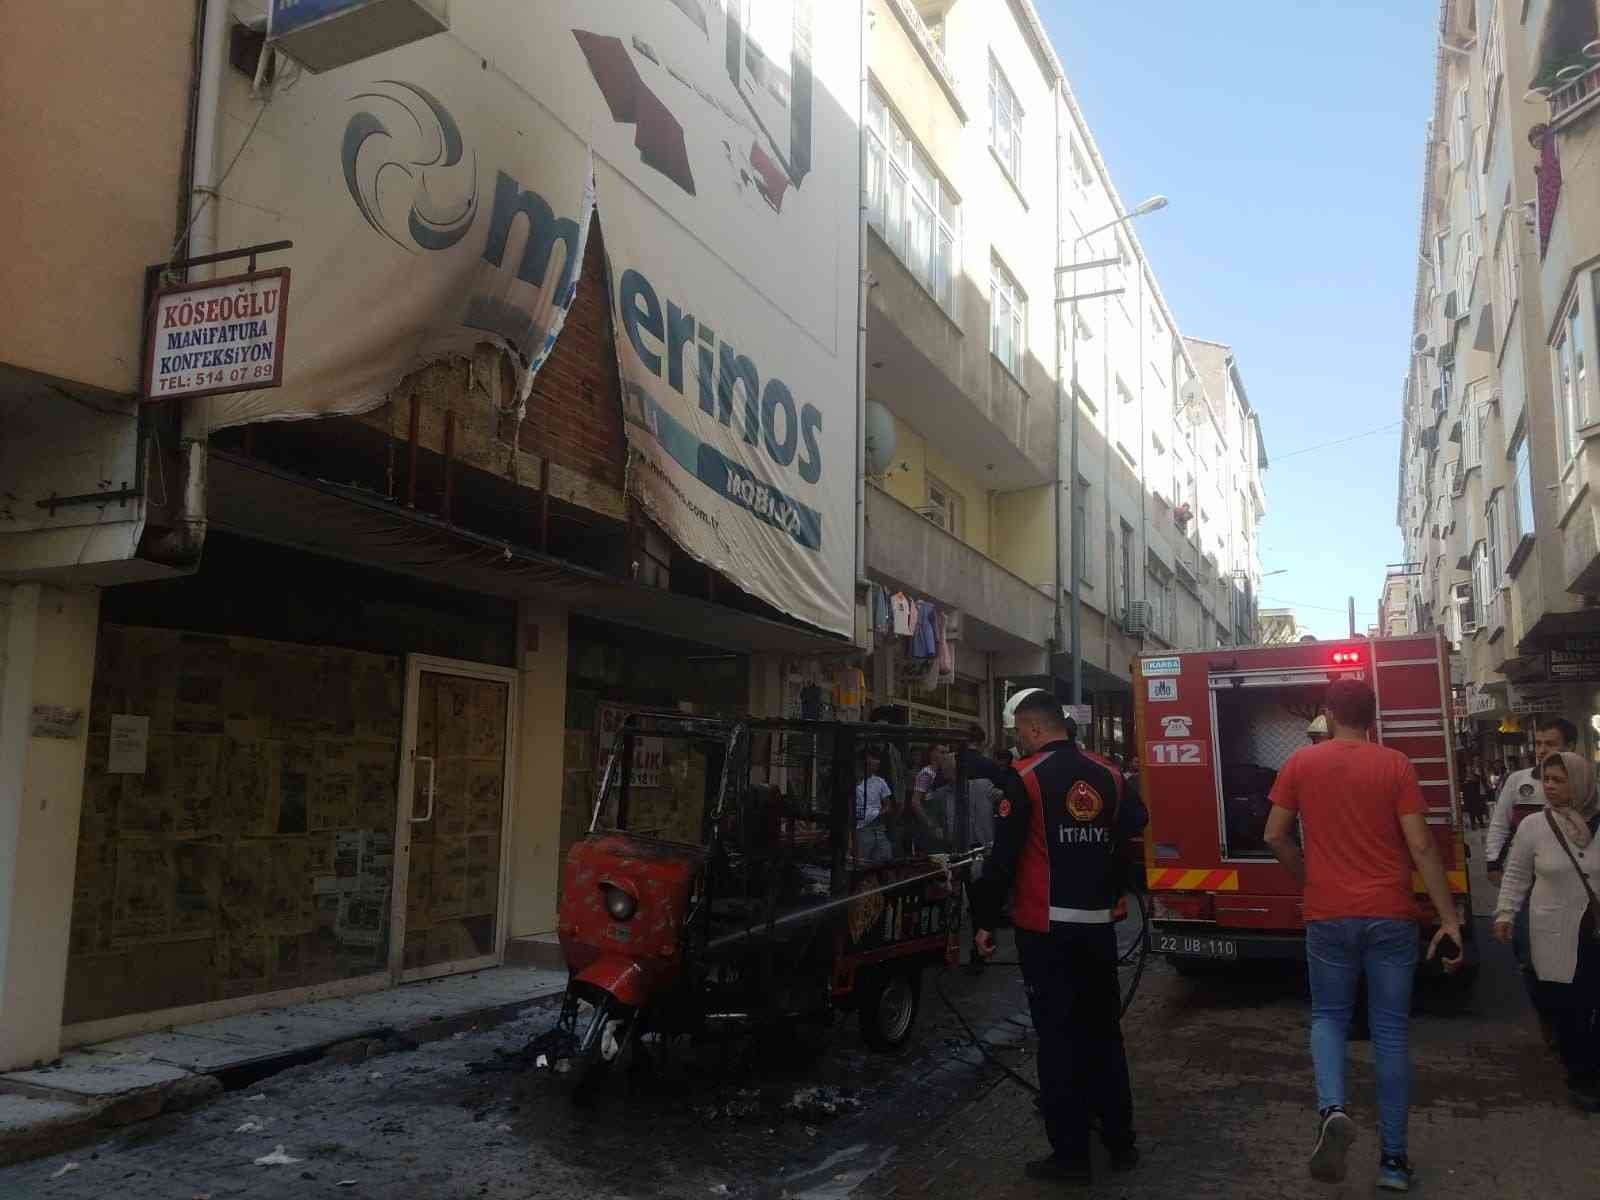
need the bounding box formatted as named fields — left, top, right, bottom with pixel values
left=867, top=486, right=1056, bottom=651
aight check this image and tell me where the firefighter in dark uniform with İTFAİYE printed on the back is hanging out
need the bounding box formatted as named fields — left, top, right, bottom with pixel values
left=973, top=691, right=1146, bottom=1184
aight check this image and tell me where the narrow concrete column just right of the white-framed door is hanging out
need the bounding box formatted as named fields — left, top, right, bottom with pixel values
left=507, top=600, right=566, bottom=938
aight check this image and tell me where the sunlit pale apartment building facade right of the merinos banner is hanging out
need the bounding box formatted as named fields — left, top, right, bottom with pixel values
left=864, top=0, right=1266, bottom=752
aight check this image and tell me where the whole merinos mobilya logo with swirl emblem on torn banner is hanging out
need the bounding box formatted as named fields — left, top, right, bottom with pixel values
left=341, top=80, right=824, bottom=550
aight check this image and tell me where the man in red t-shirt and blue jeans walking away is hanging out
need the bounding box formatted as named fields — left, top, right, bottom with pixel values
left=1266, top=678, right=1461, bottom=1192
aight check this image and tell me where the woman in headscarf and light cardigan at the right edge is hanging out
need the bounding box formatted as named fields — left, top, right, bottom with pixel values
left=1494, top=754, right=1600, bottom=1112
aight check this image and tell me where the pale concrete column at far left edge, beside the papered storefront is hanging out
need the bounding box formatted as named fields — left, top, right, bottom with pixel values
left=0, top=582, right=99, bottom=1069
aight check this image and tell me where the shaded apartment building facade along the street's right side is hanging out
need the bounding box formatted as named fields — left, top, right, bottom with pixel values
left=1397, top=0, right=1600, bottom=761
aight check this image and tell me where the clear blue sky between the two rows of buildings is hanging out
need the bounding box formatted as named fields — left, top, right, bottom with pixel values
left=1037, top=0, right=1438, bottom=637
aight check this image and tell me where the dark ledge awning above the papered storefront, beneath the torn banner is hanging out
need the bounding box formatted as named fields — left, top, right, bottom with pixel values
left=206, top=450, right=853, bottom=654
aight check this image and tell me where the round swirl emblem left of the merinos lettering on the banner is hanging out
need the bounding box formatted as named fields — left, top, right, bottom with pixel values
left=339, top=80, right=478, bottom=253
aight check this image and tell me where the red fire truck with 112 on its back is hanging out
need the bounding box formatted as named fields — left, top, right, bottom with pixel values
left=1133, top=634, right=1477, bottom=978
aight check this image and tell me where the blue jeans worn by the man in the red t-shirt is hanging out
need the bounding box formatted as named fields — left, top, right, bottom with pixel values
left=1306, top=917, right=1419, bottom=1155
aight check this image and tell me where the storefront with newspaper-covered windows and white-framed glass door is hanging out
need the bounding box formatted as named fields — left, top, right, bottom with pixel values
left=64, top=533, right=517, bottom=1042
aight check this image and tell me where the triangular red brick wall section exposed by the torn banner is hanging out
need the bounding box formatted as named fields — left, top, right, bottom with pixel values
left=507, top=221, right=624, bottom=488
